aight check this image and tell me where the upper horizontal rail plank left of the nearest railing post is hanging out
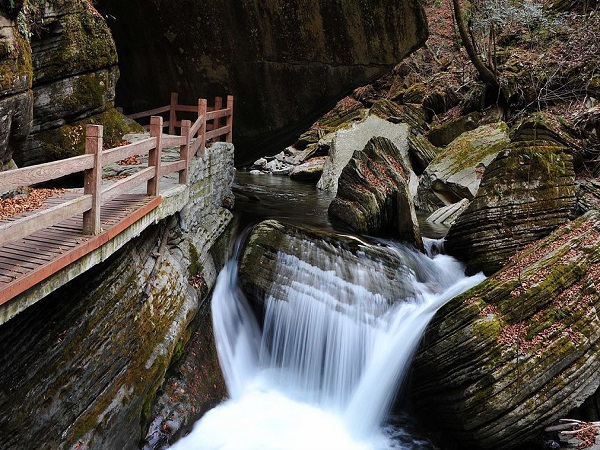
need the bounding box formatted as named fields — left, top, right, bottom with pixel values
left=0, top=155, right=94, bottom=192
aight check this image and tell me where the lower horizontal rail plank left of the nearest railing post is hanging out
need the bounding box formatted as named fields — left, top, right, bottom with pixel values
left=0, top=195, right=92, bottom=245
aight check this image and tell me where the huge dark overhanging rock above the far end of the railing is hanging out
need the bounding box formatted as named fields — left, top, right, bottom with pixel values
left=101, top=0, right=427, bottom=162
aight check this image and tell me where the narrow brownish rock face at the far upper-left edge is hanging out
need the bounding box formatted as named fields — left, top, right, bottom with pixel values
left=0, top=8, right=33, bottom=171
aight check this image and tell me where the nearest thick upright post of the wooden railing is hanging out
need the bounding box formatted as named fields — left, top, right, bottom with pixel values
left=83, top=125, right=103, bottom=234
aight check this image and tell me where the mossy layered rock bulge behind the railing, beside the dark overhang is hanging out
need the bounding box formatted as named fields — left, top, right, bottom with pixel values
left=20, top=0, right=122, bottom=166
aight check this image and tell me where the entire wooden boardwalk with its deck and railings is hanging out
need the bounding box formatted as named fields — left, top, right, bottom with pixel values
left=0, top=93, right=233, bottom=324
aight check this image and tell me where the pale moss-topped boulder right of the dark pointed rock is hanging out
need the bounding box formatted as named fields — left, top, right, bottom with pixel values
left=415, top=124, right=510, bottom=212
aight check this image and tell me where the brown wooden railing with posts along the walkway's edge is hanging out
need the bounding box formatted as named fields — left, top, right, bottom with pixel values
left=0, top=96, right=233, bottom=245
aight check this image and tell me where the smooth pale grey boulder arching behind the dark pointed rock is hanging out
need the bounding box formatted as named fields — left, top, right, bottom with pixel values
left=317, top=115, right=418, bottom=193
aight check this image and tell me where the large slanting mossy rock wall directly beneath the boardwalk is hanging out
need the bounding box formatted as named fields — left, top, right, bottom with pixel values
left=0, top=225, right=197, bottom=449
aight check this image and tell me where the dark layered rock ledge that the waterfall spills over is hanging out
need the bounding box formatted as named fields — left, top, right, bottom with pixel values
left=239, top=220, right=426, bottom=317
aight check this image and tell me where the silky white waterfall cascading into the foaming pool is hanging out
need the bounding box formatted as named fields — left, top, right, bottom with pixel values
left=172, top=237, right=484, bottom=450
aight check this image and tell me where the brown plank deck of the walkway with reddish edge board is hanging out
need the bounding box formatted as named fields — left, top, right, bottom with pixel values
left=0, top=192, right=162, bottom=305
